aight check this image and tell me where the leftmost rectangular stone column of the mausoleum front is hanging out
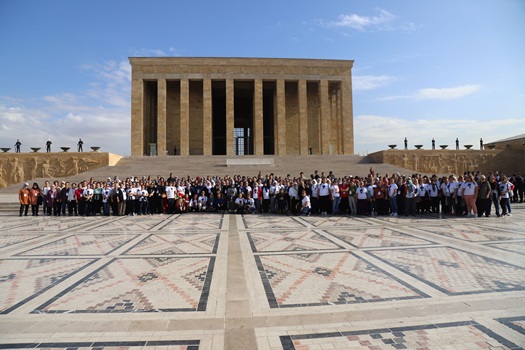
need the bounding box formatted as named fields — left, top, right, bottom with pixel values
left=131, top=79, right=144, bottom=156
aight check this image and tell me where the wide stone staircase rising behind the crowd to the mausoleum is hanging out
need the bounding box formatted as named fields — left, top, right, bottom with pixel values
left=0, top=155, right=412, bottom=196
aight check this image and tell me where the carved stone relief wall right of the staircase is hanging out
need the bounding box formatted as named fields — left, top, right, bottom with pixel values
left=368, top=150, right=525, bottom=174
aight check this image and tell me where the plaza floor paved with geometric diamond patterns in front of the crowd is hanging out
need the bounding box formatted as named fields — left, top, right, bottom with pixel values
left=0, top=204, right=525, bottom=350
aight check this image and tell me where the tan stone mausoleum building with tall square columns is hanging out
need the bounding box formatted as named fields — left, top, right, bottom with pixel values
left=129, top=57, right=354, bottom=156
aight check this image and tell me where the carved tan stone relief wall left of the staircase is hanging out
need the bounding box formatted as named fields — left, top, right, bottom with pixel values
left=0, top=152, right=122, bottom=188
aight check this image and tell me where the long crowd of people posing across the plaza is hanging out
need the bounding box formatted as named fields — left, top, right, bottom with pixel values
left=19, top=168, right=524, bottom=217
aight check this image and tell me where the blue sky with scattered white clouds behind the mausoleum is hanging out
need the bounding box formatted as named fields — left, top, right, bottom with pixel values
left=0, top=0, right=525, bottom=155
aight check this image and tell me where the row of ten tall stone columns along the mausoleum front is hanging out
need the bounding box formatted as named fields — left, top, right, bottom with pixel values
left=131, top=79, right=353, bottom=155
